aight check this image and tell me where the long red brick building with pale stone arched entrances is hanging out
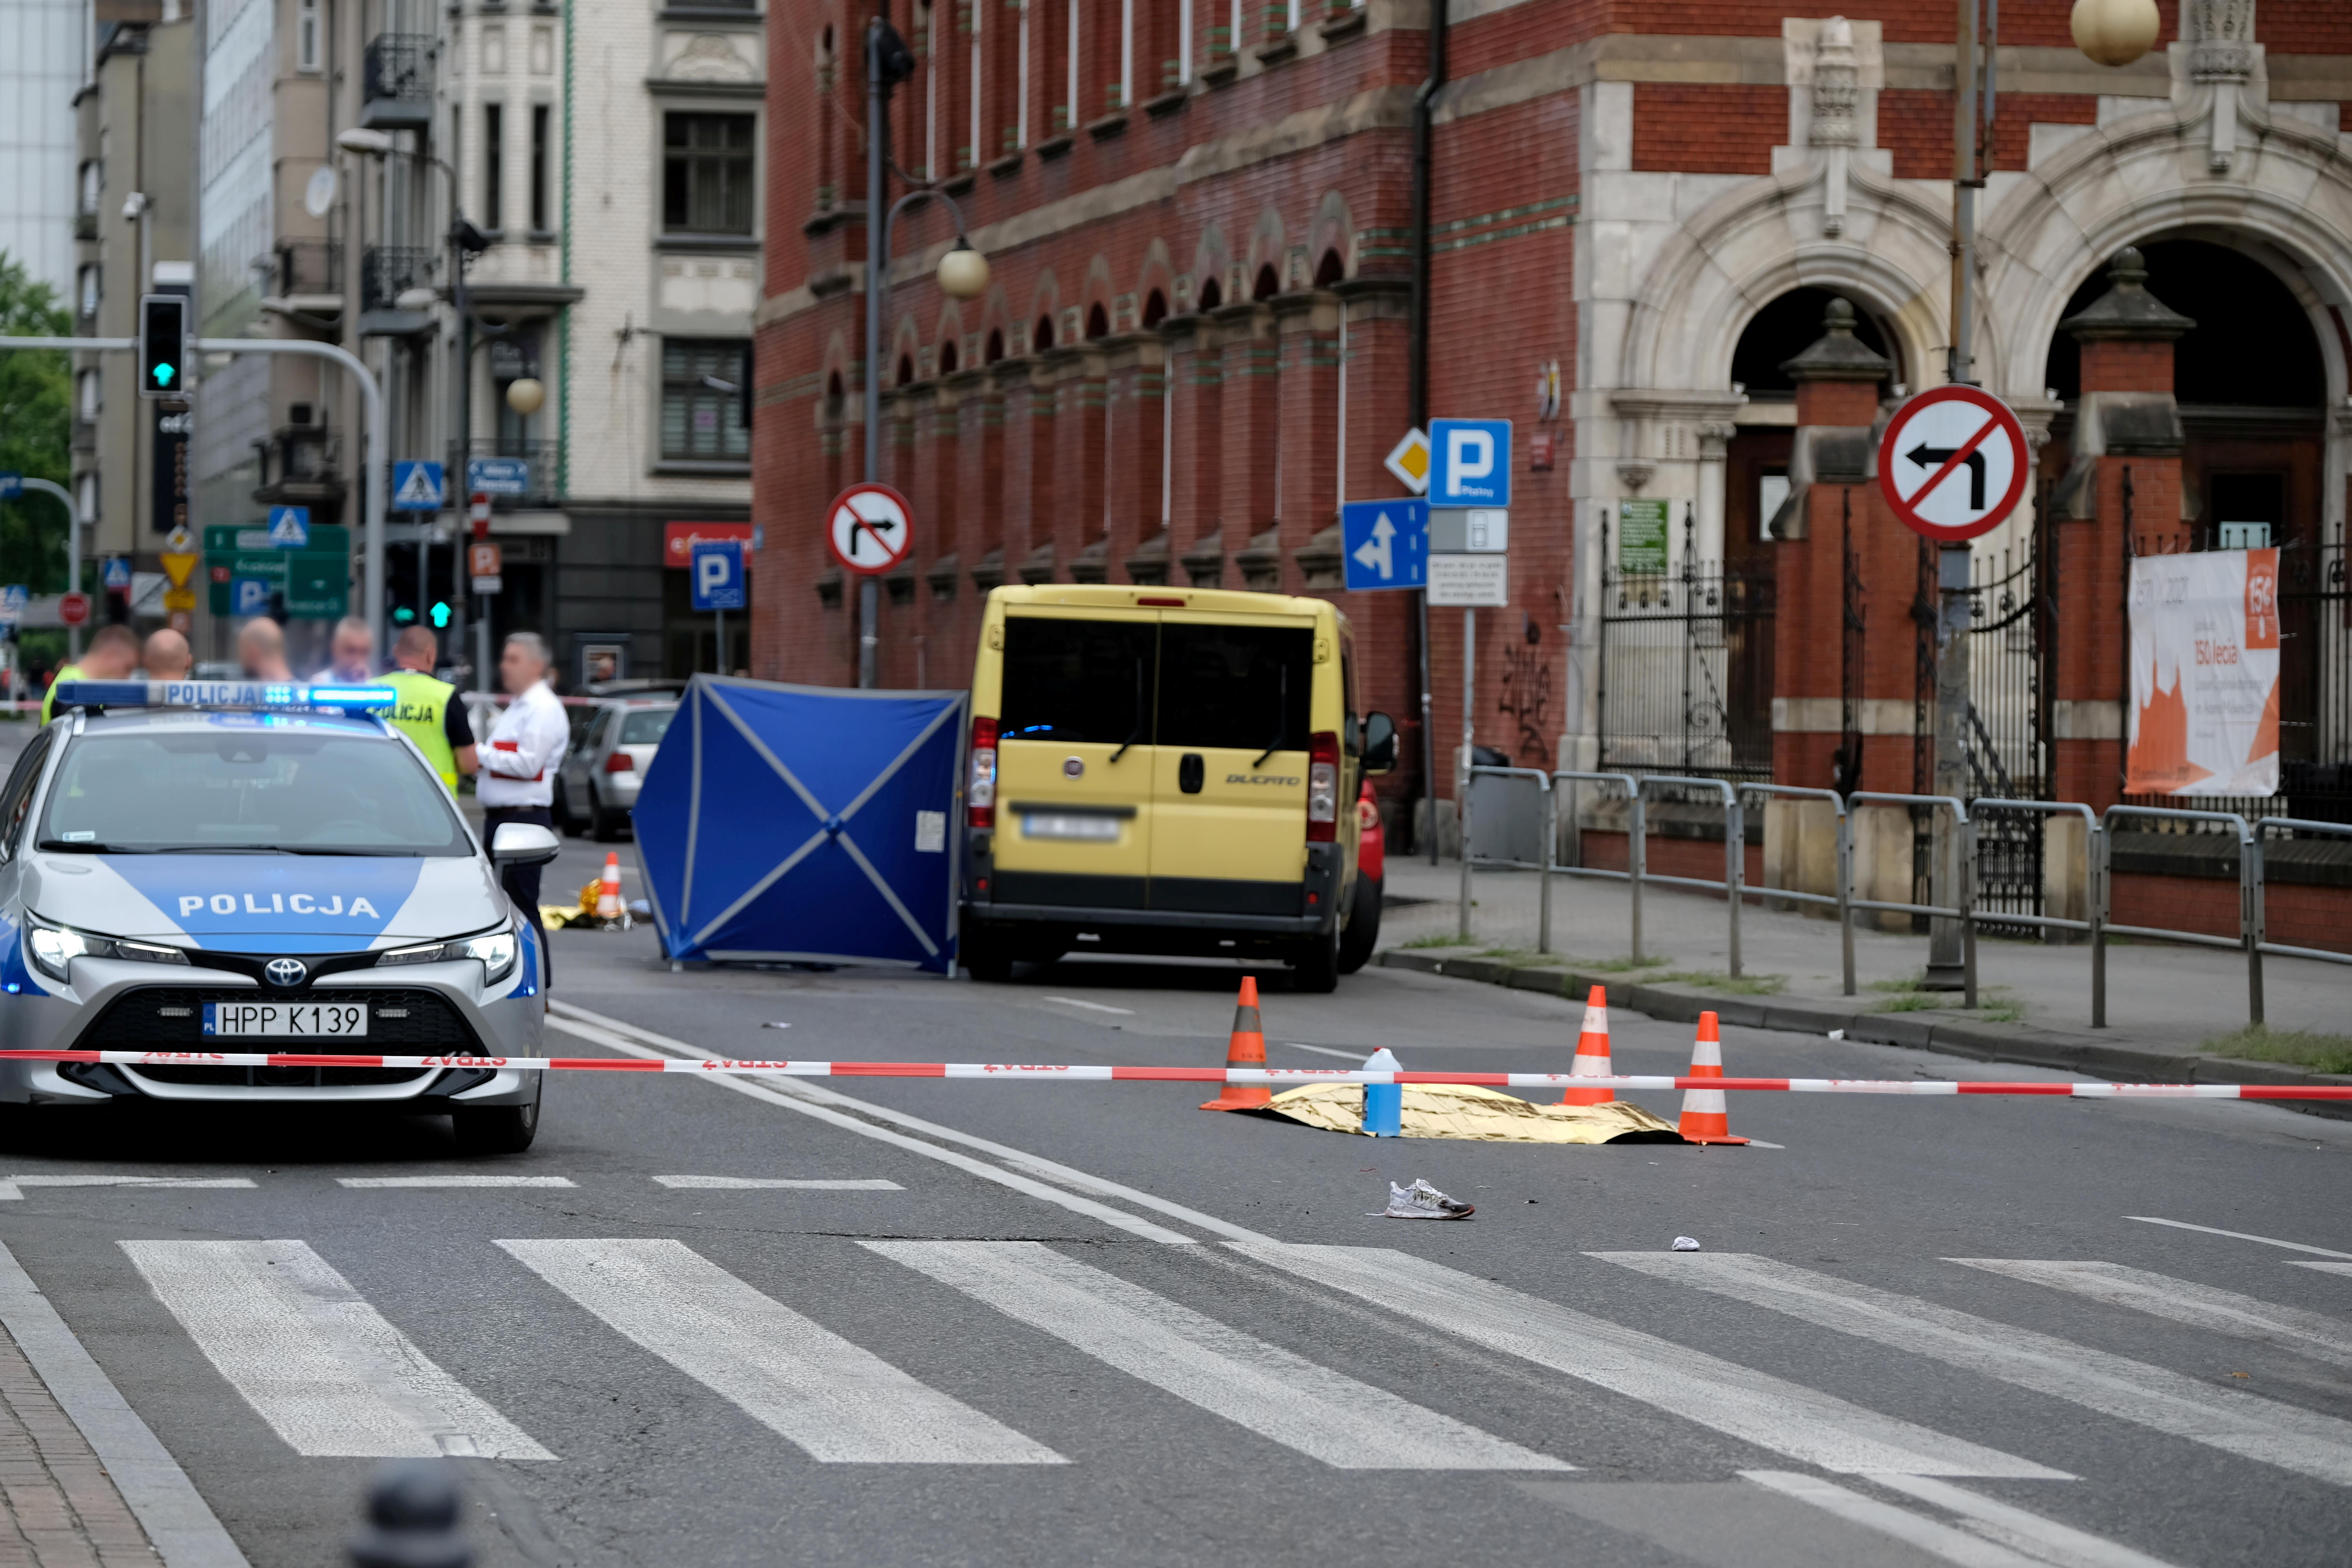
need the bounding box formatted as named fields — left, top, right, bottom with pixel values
left=750, top=0, right=2352, bottom=846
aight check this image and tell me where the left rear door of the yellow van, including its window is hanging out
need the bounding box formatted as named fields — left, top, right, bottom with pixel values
left=995, top=606, right=1160, bottom=910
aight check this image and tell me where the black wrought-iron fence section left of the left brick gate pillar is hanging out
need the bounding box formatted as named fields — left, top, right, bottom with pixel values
left=1597, top=508, right=1773, bottom=780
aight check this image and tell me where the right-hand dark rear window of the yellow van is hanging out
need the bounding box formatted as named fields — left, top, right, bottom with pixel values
left=1157, top=621, right=1315, bottom=752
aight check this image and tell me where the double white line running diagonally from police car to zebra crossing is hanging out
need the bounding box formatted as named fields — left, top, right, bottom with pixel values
left=548, top=997, right=1272, bottom=1241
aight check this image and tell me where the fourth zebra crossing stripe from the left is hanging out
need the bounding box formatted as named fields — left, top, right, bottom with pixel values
left=1235, top=1243, right=2070, bottom=1481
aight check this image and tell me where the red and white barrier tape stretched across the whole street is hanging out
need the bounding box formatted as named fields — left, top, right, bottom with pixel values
left=0, top=1051, right=2352, bottom=1100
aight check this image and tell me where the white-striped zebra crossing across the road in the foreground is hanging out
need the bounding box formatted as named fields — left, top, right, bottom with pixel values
left=78, top=1239, right=2352, bottom=1507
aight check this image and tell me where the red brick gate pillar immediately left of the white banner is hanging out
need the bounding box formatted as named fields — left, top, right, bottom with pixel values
left=2051, top=247, right=2197, bottom=811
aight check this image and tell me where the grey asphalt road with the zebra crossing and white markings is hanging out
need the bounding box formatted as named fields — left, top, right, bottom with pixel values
left=0, top=844, right=2352, bottom=1568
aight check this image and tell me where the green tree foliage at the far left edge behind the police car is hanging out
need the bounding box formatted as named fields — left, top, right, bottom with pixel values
left=0, top=252, right=73, bottom=592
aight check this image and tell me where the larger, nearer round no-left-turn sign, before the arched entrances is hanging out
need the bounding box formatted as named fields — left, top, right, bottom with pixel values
left=1879, top=386, right=2027, bottom=543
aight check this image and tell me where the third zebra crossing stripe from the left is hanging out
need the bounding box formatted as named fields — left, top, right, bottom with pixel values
left=858, top=1241, right=1573, bottom=1472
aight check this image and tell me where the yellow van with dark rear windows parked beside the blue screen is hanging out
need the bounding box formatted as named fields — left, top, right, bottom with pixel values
left=962, top=583, right=1397, bottom=990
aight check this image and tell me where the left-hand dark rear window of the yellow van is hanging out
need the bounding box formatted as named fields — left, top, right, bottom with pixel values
left=997, top=616, right=1160, bottom=745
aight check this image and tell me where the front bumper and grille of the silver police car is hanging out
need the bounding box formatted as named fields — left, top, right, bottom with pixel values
left=0, top=947, right=546, bottom=1112
